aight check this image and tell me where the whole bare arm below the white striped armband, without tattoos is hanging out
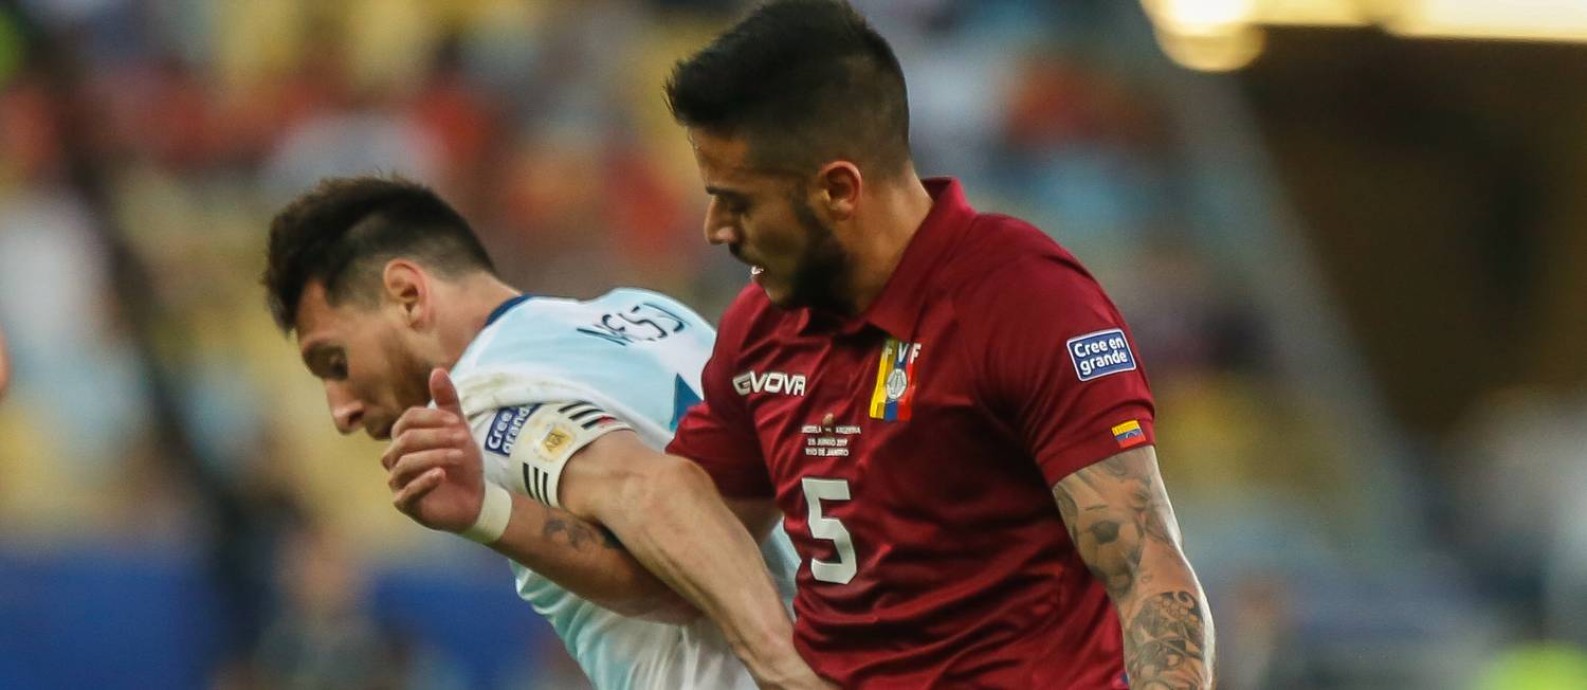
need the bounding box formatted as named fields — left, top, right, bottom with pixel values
left=560, top=431, right=822, bottom=687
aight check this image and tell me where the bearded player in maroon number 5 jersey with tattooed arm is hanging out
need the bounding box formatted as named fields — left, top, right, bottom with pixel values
left=653, top=0, right=1212, bottom=688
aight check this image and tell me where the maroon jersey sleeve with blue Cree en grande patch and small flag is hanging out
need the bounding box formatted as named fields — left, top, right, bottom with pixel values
left=968, top=255, right=1155, bottom=485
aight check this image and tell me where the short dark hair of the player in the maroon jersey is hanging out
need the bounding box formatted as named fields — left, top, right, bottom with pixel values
left=667, top=0, right=909, bottom=174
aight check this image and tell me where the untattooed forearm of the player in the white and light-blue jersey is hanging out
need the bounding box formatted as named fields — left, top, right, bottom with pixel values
left=598, top=458, right=808, bottom=685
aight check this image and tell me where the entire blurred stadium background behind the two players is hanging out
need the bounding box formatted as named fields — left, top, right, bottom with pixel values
left=0, top=0, right=1587, bottom=690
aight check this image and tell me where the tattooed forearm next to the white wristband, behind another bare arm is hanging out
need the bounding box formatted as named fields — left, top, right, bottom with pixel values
left=490, top=495, right=700, bottom=623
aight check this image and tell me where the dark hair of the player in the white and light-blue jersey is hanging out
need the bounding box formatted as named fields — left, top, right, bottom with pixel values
left=262, top=176, right=495, bottom=332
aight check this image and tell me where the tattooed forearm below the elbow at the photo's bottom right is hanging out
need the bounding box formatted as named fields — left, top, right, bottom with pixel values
left=1114, top=554, right=1214, bottom=690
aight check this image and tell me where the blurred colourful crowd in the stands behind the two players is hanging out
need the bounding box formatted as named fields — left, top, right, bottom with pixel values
left=0, top=0, right=1587, bottom=690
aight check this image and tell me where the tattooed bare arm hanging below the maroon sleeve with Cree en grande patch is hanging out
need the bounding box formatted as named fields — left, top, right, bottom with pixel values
left=1052, top=446, right=1214, bottom=690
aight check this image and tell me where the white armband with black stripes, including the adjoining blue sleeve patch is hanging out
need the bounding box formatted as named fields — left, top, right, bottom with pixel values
left=484, top=401, right=632, bottom=508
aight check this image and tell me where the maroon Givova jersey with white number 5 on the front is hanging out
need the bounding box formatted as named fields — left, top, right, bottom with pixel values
left=670, top=181, right=1152, bottom=690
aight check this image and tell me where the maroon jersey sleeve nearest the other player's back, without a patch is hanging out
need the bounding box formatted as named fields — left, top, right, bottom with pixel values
left=667, top=305, right=774, bottom=498
